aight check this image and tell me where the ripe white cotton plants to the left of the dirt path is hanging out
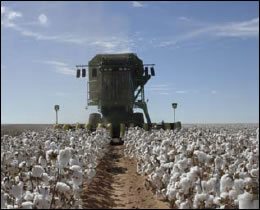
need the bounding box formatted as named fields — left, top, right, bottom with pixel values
left=1, top=129, right=110, bottom=209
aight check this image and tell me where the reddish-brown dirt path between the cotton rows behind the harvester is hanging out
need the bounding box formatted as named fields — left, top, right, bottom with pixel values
left=82, top=145, right=169, bottom=209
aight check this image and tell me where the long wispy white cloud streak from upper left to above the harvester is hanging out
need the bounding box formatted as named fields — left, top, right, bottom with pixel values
left=1, top=6, right=136, bottom=53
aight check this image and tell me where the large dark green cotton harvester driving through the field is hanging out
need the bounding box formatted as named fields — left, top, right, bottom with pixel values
left=76, top=53, right=181, bottom=142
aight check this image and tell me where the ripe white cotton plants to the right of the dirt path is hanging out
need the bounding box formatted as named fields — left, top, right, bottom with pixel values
left=124, top=126, right=259, bottom=209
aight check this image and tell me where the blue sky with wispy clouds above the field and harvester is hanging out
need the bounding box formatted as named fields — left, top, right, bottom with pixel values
left=1, top=1, right=259, bottom=123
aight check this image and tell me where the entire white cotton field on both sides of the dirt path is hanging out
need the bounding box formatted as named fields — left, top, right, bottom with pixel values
left=1, top=125, right=259, bottom=209
